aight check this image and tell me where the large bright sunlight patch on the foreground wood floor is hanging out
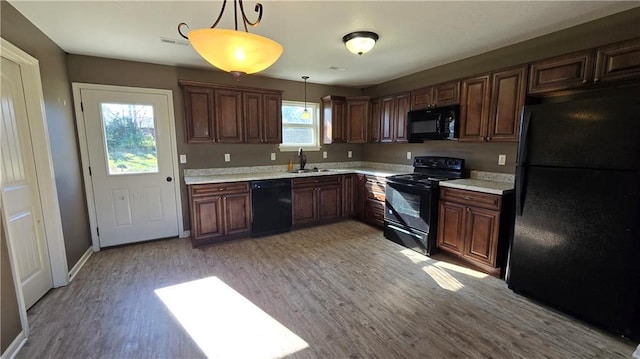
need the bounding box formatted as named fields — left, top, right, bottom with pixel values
left=155, top=277, right=309, bottom=359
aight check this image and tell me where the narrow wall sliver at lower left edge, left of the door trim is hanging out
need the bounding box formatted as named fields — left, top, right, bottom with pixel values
left=0, top=218, right=22, bottom=354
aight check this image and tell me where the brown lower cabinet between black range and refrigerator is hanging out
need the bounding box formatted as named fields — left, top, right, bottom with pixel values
left=437, top=187, right=512, bottom=274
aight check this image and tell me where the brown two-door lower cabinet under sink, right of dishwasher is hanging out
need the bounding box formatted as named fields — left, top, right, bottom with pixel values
left=291, top=176, right=342, bottom=227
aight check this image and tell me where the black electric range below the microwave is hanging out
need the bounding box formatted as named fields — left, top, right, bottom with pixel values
left=384, top=156, right=464, bottom=255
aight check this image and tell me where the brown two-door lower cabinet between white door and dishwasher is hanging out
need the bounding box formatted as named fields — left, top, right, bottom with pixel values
left=189, top=182, right=251, bottom=247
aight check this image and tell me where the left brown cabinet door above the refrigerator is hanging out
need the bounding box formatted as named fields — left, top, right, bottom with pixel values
left=528, top=50, right=594, bottom=95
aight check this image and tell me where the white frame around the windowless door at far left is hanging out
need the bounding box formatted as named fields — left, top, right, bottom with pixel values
left=0, top=37, right=69, bottom=334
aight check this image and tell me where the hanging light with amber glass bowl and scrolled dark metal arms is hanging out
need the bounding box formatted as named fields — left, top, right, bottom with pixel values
left=178, top=0, right=284, bottom=79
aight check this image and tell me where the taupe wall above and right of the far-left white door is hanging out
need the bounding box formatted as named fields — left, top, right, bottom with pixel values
left=1, top=1, right=91, bottom=269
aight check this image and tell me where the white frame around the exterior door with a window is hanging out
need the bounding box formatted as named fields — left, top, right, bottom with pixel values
left=71, top=82, right=185, bottom=252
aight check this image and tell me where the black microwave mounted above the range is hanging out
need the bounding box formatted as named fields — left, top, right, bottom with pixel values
left=407, top=105, right=460, bottom=143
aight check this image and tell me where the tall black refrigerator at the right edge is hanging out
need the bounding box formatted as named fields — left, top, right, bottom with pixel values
left=505, top=90, right=640, bottom=342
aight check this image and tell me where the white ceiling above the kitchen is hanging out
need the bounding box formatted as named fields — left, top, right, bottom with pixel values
left=9, top=0, right=640, bottom=87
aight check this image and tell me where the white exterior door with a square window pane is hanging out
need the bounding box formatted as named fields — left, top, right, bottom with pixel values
left=80, top=88, right=179, bottom=247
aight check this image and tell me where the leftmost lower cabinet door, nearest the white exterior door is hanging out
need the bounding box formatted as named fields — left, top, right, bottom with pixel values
left=191, top=196, right=224, bottom=245
